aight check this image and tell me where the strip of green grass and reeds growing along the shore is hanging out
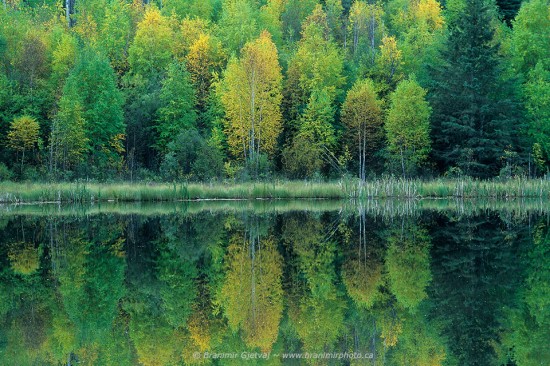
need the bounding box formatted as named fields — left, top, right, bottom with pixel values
left=0, top=178, right=550, bottom=203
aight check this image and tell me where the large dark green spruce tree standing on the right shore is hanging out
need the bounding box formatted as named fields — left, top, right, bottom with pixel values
left=431, top=0, right=522, bottom=178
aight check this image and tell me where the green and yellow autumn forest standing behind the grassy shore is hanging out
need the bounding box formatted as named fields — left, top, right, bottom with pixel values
left=0, top=0, right=550, bottom=182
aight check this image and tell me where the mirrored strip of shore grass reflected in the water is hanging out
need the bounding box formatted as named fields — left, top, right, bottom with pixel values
left=0, top=198, right=550, bottom=220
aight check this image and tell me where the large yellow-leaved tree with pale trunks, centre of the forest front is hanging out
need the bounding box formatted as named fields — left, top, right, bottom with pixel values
left=218, top=31, right=283, bottom=165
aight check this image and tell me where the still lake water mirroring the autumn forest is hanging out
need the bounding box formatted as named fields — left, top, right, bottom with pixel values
left=0, top=201, right=550, bottom=366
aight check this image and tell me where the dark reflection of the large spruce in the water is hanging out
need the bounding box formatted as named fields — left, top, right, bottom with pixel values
left=430, top=214, right=531, bottom=365
